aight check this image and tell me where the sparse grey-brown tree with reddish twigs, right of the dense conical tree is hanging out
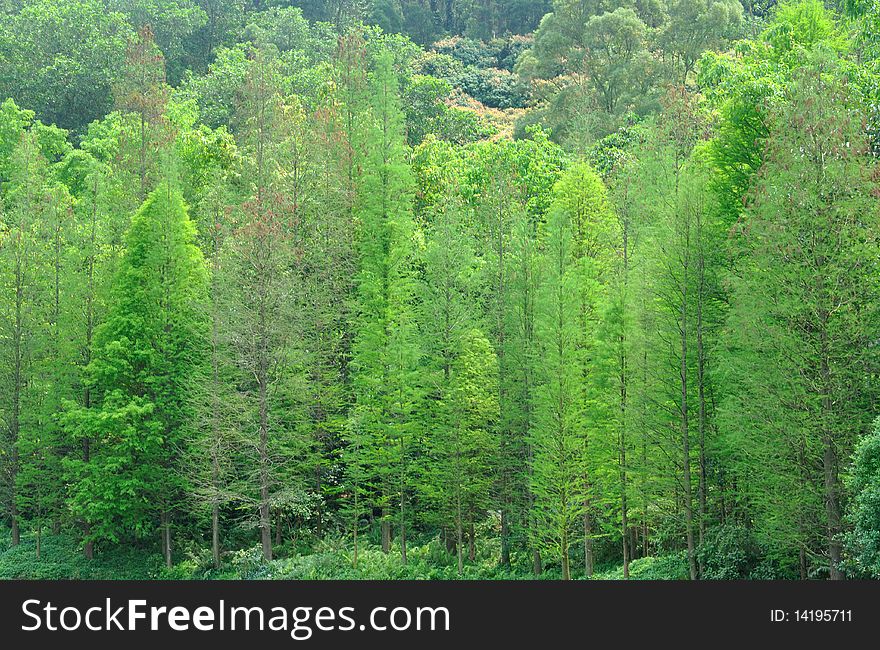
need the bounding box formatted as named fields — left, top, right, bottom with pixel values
left=226, top=48, right=302, bottom=560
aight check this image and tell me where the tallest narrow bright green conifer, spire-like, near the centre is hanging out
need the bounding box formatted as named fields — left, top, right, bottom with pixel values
left=348, top=53, right=420, bottom=562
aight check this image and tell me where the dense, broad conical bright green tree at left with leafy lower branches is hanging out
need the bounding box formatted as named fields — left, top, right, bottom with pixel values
left=65, top=180, right=208, bottom=566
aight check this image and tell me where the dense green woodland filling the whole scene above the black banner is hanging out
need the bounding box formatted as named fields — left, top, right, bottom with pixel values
left=0, top=0, right=880, bottom=579
